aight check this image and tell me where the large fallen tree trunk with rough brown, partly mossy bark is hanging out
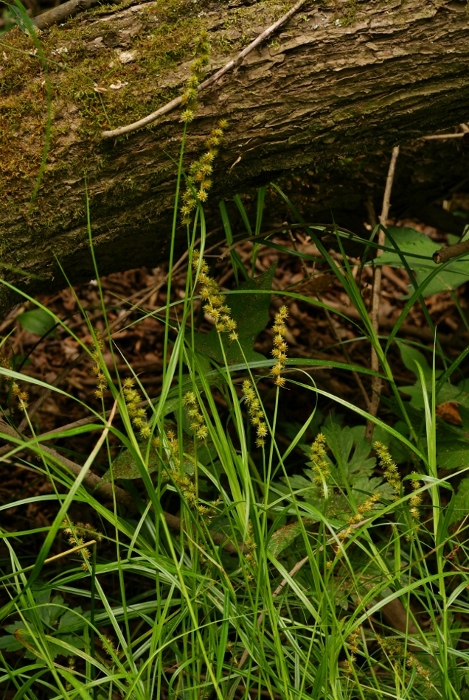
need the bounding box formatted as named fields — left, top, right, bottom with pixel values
left=0, top=0, right=469, bottom=308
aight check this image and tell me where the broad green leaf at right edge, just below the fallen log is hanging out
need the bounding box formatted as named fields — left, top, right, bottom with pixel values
left=373, top=227, right=469, bottom=297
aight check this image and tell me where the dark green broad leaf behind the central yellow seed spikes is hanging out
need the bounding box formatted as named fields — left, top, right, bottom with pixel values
left=194, top=264, right=276, bottom=364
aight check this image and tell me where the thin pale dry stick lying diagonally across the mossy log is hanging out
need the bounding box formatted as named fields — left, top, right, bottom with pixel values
left=101, top=0, right=308, bottom=139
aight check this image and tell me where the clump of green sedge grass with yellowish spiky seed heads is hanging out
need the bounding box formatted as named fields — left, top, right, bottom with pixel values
left=0, top=8, right=469, bottom=700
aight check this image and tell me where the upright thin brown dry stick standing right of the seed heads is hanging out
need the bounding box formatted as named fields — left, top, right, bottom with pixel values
left=365, top=146, right=399, bottom=440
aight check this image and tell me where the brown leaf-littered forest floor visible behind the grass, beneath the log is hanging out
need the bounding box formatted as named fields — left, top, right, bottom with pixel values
left=0, top=222, right=468, bottom=558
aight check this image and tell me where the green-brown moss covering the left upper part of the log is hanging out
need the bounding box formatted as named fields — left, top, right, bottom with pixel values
left=0, top=0, right=293, bottom=255
